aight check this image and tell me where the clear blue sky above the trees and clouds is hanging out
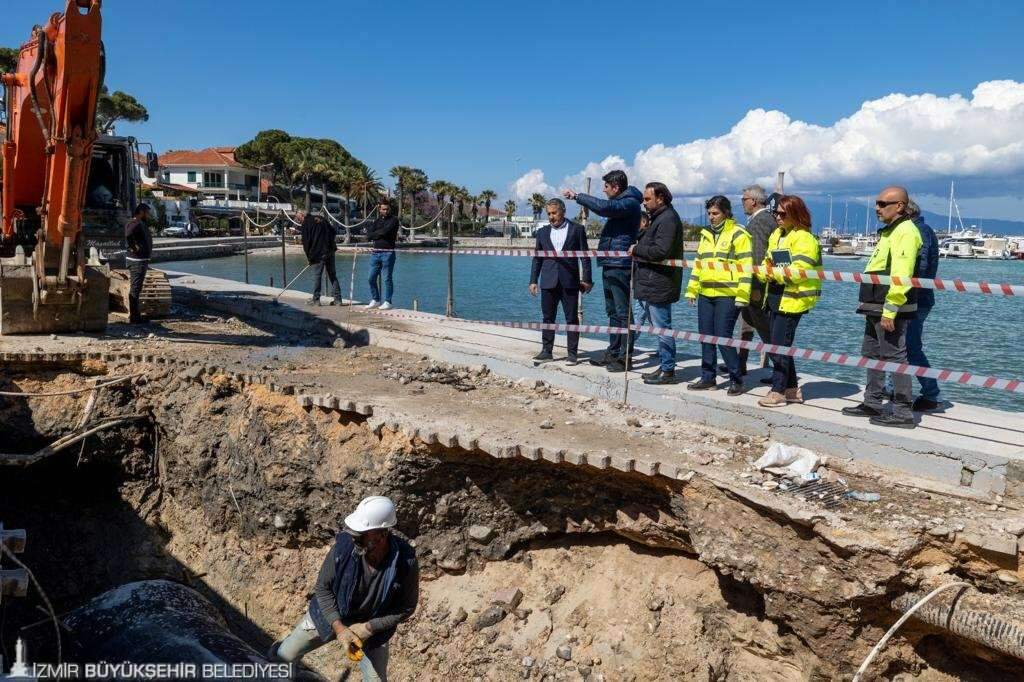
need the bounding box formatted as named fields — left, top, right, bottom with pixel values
left=0, top=0, right=1024, bottom=219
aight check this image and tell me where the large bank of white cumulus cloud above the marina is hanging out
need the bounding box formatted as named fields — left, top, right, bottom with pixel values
left=513, top=80, right=1024, bottom=197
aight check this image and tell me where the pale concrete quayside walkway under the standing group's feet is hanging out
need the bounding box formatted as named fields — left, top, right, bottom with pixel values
left=168, top=272, right=1024, bottom=497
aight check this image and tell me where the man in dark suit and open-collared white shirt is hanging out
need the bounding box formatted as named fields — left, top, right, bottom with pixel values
left=529, top=199, right=594, bottom=365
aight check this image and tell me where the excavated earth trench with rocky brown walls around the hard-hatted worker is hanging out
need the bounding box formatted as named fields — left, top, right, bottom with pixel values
left=0, top=361, right=1020, bottom=680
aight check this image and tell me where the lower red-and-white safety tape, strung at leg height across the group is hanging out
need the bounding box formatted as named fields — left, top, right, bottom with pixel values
left=369, top=308, right=1024, bottom=394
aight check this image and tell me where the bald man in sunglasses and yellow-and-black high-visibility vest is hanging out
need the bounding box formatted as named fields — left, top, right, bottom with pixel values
left=843, top=186, right=922, bottom=429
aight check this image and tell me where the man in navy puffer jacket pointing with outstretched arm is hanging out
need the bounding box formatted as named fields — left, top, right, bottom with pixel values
left=562, top=170, right=643, bottom=372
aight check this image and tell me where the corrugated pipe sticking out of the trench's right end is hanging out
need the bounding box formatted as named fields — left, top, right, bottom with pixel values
left=892, top=588, right=1024, bottom=659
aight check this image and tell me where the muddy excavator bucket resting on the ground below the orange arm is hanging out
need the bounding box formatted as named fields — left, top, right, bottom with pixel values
left=0, top=263, right=111, bottom=335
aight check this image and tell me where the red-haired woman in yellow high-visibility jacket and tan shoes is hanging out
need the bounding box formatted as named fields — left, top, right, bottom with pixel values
left=758, top=196, right=821, bottom=408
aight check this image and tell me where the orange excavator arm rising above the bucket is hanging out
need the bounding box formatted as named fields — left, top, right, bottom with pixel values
left=0, top=0, right=109, bottom=333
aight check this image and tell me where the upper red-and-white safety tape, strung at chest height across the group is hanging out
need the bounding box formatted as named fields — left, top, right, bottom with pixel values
left=339, top=247, right=1024, bottom=296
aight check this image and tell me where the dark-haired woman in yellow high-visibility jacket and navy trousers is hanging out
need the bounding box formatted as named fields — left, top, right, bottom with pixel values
left=686, top=195, right=754, bottom=395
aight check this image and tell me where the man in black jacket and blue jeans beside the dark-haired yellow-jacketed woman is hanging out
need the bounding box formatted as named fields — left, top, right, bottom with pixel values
left=630, top=182, right=683, bottom=384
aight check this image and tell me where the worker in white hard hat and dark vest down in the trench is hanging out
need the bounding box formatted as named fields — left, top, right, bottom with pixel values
left=270, top=496, right=420, bottom=681
